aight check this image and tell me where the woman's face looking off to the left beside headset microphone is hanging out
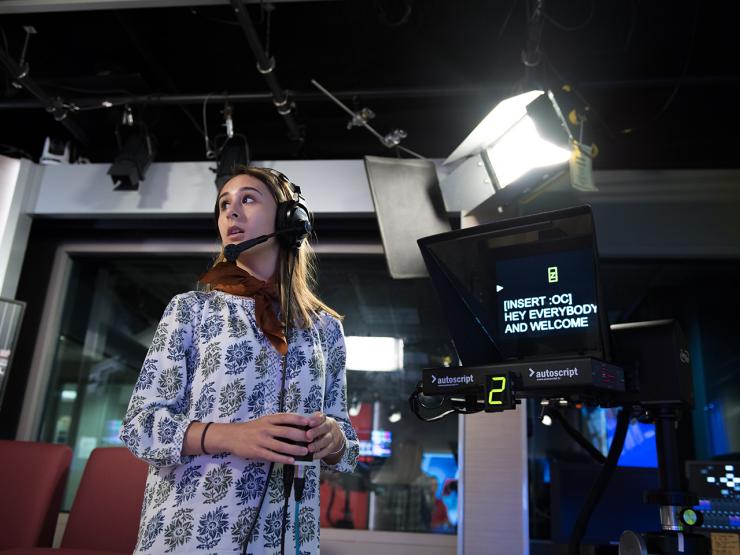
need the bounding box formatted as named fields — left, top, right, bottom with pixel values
left=218, top=175, right=277, bottom=245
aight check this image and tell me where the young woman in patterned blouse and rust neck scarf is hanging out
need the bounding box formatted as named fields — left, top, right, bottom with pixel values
left=121, top=167, right=359, bottom=554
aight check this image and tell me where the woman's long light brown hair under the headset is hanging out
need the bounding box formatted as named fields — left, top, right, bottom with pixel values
left=208, top=166, right=341, bottom=328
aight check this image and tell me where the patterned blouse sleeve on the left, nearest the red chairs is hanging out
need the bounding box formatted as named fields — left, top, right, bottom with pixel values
left=120, top=295, right=195, bottom=468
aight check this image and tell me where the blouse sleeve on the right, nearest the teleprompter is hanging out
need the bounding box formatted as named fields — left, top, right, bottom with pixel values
left=321, top=318, right=360, bottom=472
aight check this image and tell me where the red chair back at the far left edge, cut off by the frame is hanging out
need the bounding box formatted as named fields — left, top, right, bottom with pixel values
left=0, top=440, right=72, bottom=550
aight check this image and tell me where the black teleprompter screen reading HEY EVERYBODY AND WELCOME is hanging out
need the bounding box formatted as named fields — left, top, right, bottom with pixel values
left=419, top=206, right=610, bottom=366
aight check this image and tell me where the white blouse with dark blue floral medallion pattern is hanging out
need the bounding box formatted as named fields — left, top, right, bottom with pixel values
left=121, top=291, right=359, bottom=555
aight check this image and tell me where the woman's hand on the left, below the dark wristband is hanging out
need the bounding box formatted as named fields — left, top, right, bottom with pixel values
left=205, top=412, right=310, bottom=464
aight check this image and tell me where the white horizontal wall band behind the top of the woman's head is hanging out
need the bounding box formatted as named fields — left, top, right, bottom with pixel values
left=32, top=160, right=375, bottom=218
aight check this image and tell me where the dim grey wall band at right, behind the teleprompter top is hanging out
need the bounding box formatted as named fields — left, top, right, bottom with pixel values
left=470, top=170, right=740, bottom=258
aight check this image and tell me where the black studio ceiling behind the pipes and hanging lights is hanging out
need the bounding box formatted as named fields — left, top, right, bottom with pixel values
left=0, top=0, right=740, bottom=169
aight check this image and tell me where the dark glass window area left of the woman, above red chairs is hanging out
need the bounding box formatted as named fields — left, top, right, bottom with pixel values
left=40, top=256, right=209, bottom=510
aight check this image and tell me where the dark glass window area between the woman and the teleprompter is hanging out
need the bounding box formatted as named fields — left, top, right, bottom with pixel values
left=319, top=256, right=458, bottom=533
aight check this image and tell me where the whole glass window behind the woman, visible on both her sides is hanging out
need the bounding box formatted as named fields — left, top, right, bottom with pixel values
left=40, top=255, right=458, bottom=533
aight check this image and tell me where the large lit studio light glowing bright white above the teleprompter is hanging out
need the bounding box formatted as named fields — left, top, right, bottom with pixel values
left=441, top=90, right=573, bottom=210
